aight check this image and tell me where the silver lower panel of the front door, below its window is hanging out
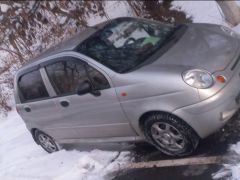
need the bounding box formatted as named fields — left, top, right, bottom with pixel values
left=49, top=88, right=135, bottom=139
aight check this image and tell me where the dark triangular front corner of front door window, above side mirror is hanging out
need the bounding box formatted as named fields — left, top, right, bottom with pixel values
left=87, top=66, right=110, bottom=90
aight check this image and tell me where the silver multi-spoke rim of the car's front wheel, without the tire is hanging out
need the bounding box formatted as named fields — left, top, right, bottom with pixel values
left=151, top=122, right=186, bottom=152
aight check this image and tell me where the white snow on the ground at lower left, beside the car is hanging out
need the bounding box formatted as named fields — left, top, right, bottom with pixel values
left=0, top=111, right=130, bottom=180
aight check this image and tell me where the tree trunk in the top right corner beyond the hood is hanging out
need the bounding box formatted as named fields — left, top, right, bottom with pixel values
left=216, top=0, right=240, bottom=26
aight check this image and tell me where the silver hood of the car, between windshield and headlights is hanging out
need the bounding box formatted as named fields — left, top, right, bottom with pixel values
left=153, top=24, right=239, bottom=73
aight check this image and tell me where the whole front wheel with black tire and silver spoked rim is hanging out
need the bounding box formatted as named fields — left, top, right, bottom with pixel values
left=143, top=113, right=200, bottom=156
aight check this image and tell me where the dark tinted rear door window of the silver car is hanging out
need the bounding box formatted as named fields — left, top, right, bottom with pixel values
left=18, top=70, right=49, bottom=101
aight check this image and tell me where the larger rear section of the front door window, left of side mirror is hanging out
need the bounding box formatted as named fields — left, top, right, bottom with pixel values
left=46, top=57, right=89, bottom=95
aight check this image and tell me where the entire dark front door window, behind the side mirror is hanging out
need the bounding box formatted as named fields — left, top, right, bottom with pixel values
left=46, top=57, right=110, bottom=95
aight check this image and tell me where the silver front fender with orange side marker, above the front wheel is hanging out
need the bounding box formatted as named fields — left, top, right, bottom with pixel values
left=113, top=66, right=199, bottom=135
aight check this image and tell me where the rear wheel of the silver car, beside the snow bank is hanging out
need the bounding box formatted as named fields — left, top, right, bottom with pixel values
left=34, top=130, right=61, bottom=153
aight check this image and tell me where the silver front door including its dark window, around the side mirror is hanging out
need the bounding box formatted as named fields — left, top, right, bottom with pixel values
left=44, top=56, right=135, bottom=138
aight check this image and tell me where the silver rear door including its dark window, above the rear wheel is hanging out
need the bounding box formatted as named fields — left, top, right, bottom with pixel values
left=17, top=68, right=71, bottom=138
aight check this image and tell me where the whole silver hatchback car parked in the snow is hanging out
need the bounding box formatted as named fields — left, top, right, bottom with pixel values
left=14, top=17, right=240, bottom=156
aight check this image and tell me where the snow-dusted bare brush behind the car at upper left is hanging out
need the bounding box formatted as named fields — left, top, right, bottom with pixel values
left=0, top=0, right=107, bottom=113
